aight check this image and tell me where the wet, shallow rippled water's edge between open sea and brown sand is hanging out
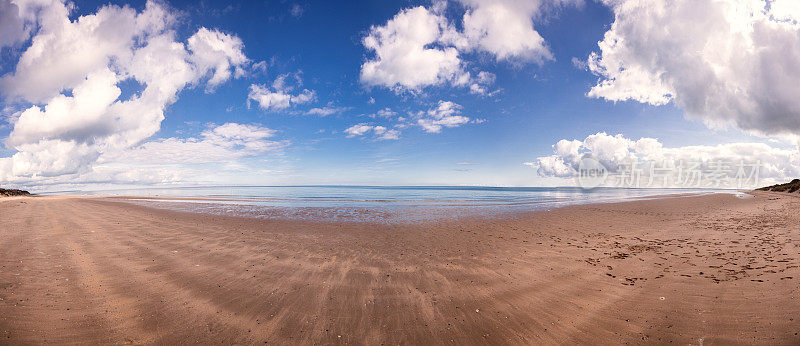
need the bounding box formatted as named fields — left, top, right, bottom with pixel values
left=25, top=190, right=736, bottom=224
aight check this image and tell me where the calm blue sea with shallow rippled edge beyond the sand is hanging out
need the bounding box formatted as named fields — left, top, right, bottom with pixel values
left=45, top=185, right=742, bottom=223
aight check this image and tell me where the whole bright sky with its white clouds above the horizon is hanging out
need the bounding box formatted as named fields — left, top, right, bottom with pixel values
left=0, top=0, right=800, bottom=191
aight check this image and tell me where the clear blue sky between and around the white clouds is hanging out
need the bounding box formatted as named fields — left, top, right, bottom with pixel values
left=0, top=0, right=797, bottom=189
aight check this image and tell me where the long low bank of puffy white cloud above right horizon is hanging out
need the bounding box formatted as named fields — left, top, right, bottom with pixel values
left=526, top=132, right=800, bottom=187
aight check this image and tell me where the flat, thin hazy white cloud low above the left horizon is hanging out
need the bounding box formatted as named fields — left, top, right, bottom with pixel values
left=0, top=123, right=289, bottom=191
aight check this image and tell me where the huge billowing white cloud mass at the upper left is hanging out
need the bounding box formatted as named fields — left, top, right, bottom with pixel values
left=0, top=1, right=248, bottom=180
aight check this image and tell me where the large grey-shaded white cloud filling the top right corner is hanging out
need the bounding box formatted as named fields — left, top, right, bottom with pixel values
left=587, top=0, right=800, bottom=135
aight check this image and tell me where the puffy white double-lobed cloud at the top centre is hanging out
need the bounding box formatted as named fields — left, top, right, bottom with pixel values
left=361, top=0, right=581, bottom=94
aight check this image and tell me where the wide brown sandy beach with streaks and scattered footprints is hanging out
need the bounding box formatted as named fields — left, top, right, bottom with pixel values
left=0, top=193, right=800, bottom=344
